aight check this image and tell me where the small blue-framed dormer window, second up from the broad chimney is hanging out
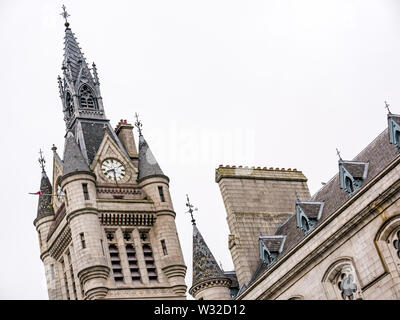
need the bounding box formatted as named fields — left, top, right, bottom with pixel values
left=296, top=201, right=324, bottom=235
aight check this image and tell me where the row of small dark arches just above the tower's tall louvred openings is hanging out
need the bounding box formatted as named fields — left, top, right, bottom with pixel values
left=99, top=213, right=157, bottom=226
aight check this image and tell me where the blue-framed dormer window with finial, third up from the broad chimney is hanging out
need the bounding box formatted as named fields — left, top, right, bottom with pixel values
left=339, top=160, right=368, bottom=195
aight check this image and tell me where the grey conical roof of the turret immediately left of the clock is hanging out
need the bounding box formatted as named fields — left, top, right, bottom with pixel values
left=63, top=132, right=90, bottom=175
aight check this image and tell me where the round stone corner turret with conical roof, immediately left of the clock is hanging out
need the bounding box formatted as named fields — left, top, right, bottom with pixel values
left=60, top=132, right=110, bottom=299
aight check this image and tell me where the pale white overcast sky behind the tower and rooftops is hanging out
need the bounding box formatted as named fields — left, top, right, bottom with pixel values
left=0, top=0, right=400, bottom=299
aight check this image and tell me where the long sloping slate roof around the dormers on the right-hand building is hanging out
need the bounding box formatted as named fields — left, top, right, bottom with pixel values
left=249, top=128, right=399, bottom=285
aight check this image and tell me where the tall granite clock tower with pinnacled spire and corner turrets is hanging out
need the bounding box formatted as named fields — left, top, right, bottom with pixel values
left=34, top=7, right=186, bottom=299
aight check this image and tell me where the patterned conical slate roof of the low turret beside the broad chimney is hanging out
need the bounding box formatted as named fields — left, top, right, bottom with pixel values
left=192, top=225, right=226, bottom=286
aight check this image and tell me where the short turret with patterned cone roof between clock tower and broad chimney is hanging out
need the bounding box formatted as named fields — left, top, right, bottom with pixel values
left=189, top=220, right=232, bottom=300
